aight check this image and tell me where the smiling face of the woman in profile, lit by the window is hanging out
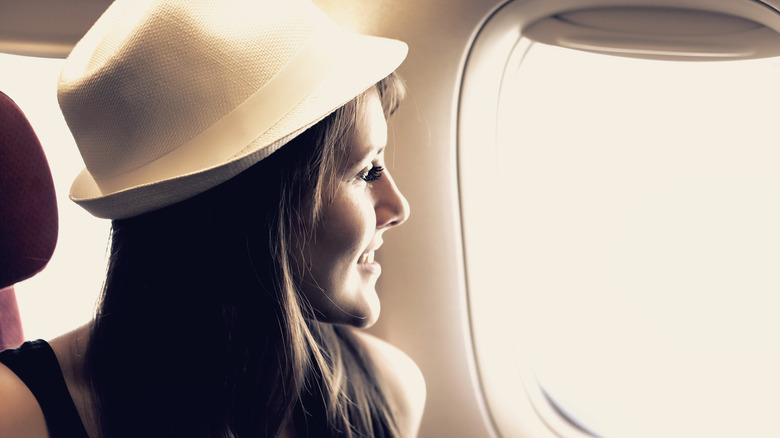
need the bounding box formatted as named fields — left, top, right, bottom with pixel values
left=301, top=90, right=409, bottom=327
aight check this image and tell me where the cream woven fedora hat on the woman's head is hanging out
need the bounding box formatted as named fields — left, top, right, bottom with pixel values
left=58, top=0, right=407, bottom=219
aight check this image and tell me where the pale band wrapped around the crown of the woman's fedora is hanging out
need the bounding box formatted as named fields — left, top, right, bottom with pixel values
left=93, top=27, right=342, bottom=195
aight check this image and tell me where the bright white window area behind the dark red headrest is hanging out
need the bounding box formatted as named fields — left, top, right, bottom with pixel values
left=0, top=54, right=110, bottom=339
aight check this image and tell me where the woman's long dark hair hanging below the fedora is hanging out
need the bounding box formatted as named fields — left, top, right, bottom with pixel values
left=84, top=74, right=403, bottom=438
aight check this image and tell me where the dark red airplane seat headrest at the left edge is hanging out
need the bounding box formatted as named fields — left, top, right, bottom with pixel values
left=0, top=92, right=59, bottom=351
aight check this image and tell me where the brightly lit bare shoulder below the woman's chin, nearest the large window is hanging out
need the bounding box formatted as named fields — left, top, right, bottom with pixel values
left=355, top=330, right=426, bottom=437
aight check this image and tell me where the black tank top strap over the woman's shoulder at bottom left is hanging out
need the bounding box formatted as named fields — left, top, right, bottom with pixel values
left=0, top=340, right=89, bottom=438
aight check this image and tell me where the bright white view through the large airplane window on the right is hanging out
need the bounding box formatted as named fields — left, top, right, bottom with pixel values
left=496, top=44, right=780, bottom=438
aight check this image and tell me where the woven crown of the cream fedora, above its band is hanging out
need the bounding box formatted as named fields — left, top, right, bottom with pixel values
left=58, top=0, right=330, bottom=178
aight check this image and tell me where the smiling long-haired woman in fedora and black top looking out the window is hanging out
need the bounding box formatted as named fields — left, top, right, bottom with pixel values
left=0, top=0, right=425, bottom=438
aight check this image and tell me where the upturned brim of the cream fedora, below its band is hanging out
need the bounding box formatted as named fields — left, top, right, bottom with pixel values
left=70, top=35, right=408, bottom=219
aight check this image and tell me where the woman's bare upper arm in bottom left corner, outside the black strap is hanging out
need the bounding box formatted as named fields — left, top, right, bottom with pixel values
left=0, top=364, right=49, bottom=438
